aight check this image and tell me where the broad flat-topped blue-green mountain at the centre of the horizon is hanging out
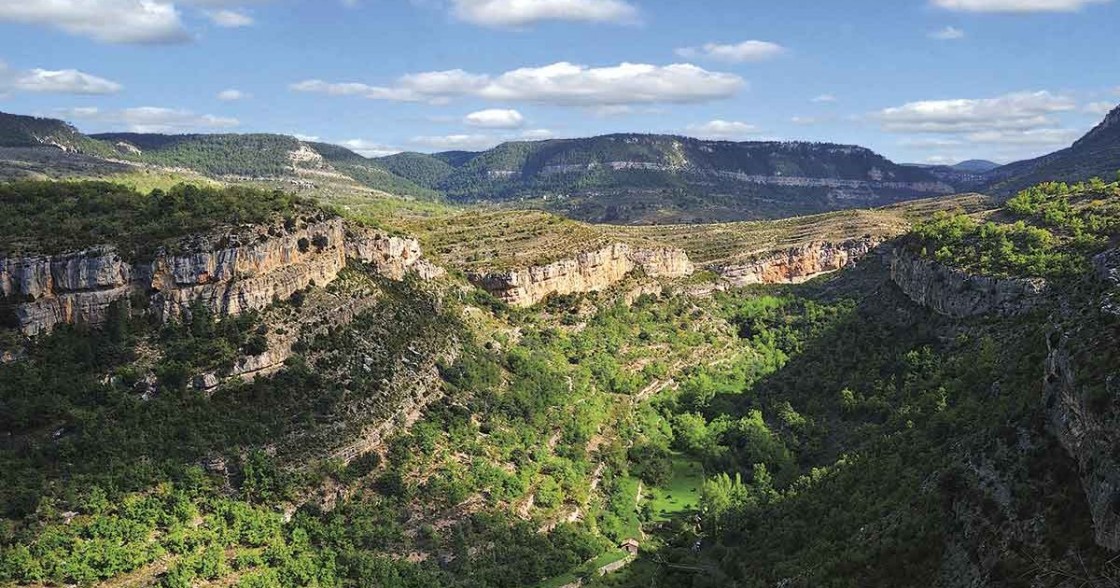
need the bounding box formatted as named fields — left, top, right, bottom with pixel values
left=377, top=134, right=956, bottom=223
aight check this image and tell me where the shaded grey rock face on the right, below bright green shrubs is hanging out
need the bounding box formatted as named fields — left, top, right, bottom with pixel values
left=890, top=250, right=1046, bottom=318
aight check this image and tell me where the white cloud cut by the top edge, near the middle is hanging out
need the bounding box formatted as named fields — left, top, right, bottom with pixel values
left=451, top=0, right=638, bottom=28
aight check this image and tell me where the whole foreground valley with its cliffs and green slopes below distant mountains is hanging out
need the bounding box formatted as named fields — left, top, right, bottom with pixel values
left=0, top=176, right=1120, bottom=588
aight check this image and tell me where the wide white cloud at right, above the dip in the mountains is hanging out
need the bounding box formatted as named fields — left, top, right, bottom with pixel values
left=874, top=92, right=1076, bottom=133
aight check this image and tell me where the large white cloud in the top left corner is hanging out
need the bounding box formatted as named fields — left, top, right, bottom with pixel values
left=0, top=0, right=189, bottom=44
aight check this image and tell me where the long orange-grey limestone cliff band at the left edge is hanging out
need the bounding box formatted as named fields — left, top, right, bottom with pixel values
left=0, top=217, right=441, bottom=336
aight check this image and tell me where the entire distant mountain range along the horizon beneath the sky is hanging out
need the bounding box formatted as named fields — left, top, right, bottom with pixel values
left=0, top=103, right=1120, bottom=223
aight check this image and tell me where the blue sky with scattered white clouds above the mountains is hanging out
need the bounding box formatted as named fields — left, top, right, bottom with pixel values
left=0, top=0, right=1120, bottom=164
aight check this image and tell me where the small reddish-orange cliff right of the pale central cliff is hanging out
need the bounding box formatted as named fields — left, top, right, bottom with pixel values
left=718, top=239, right=878, bottom=286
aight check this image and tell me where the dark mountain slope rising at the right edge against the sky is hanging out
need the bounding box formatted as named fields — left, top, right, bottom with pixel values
left=987, top=106, right=1120, bottom=197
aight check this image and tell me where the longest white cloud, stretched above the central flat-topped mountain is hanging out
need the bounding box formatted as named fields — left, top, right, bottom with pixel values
left=291, top=62, right=746, bottom=108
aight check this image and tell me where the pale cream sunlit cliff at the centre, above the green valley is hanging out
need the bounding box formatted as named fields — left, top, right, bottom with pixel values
left=467, top=243, right=696, bottom=307
